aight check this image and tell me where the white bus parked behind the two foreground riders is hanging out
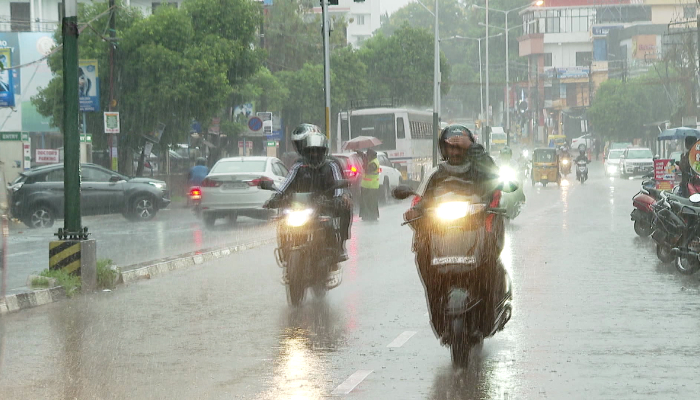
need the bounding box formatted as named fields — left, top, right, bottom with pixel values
left=336, top=108, right=433, bottom=182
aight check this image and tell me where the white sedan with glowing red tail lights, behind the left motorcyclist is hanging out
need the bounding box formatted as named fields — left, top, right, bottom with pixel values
left=201, top=157, right=288, bottom=227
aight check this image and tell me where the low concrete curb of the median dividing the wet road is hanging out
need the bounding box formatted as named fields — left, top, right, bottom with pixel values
left=0, top=238, right=277, bottom=315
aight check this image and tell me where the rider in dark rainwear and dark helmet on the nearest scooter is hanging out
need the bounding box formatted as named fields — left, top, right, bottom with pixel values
left=404, top=125, right=505, bottom=340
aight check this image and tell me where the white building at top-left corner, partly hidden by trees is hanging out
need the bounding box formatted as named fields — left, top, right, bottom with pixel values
left=0, top=0, right=182, bottom=32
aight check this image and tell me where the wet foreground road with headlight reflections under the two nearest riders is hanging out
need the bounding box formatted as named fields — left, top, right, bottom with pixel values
left=0, top=164, right=700, bottom=399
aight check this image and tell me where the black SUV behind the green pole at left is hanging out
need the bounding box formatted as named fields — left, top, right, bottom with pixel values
left=9, top=164, right=170, bottom=228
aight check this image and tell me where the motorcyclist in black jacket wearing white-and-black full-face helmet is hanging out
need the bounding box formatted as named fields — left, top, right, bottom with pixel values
left=263, top=124, right=352, bottom=262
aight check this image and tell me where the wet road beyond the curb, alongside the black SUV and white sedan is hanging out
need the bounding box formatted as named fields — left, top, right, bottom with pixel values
left=7, top=205, right=275, bottom=293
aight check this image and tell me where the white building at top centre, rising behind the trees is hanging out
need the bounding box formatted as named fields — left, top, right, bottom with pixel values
left=313, top=0, right=381, bottom=48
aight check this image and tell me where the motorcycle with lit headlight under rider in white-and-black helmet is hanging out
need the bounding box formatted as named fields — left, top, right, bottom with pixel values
left=260, top=180, right=348, bottom=306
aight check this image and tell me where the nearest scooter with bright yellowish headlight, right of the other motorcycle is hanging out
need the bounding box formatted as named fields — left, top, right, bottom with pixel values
left=393, top=178, right=514, bottom=367
